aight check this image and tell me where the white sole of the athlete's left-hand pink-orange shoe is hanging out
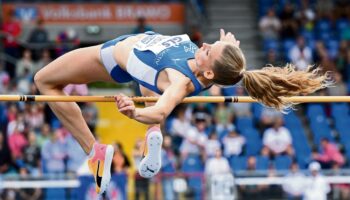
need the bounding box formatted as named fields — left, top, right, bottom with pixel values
left=99, top=145, right=114, bottom=194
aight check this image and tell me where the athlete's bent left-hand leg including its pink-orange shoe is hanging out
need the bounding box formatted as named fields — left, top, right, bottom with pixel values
left=35, top=46, right=114, bottom=193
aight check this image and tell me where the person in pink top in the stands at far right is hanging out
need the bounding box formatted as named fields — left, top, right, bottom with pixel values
left=312, top=138, right=345, bottom=169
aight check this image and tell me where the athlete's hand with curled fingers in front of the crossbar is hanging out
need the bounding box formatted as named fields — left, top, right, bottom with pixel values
left=114, top=94, right=135, bottom=119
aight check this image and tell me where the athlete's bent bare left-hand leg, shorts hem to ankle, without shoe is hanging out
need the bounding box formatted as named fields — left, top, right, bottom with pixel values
left=34, top=46, right=112, bottom=154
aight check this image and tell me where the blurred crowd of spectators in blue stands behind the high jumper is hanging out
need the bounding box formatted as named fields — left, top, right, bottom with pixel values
left=0, top=0, right=350, bottom=200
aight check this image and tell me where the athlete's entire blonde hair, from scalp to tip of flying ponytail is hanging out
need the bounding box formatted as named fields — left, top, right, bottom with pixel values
left=213, top=45, right=332, bottom=111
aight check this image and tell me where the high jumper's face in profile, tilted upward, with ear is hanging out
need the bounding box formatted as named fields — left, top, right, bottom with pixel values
left=195, top=41, right=229, bottom=79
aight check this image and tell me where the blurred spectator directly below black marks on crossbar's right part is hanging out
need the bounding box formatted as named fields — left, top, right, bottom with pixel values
left=214, top=103, right=233, bottom=134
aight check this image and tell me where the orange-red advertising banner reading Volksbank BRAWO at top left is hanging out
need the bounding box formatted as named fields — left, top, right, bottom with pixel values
left=2, top=3, right=184, bottom=24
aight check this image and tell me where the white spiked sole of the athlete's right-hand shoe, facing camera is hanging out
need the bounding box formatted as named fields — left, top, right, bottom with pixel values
left=139, top=132, right=163, bottom=178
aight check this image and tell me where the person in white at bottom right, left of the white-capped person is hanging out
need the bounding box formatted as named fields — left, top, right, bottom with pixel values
left=282, top=162, right=306, bottom=200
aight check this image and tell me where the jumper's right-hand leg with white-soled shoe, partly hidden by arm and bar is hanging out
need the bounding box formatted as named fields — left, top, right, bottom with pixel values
left=138, top=86, right=163, bottom=178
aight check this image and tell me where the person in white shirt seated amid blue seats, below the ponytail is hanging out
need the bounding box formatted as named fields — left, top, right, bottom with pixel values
left=261, top=117, right=294, bottom=156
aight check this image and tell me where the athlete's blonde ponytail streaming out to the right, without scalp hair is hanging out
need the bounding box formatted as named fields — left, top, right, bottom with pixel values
left=242, top=64, right=332, bottom=111
